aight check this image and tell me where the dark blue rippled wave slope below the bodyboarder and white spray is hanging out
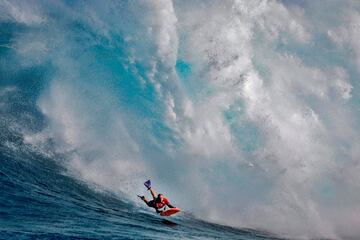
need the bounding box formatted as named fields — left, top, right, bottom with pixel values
left=0, top=141, right=278, bottom=239
